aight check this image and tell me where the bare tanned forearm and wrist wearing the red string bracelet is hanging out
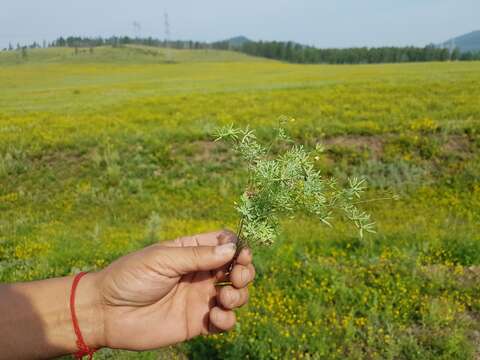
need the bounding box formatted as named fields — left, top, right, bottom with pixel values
left=0, top=274, right=103, bottom=360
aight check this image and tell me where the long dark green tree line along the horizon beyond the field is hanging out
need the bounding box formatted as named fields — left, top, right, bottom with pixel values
left=4, top=36, right=480, bottom=64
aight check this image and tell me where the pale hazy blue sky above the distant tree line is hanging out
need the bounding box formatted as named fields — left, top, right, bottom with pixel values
left=0, top=0, right=480, bottom=48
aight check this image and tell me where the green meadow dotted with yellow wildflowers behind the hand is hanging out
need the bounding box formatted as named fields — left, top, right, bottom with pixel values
left=0, top=47, right=480, bottom=359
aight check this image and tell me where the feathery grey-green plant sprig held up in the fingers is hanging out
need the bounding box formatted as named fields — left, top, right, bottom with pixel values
left=216, top=121, right=374, bottom=248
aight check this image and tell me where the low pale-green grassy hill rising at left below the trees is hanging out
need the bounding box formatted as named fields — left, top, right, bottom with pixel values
left=0, top=45, right=267, bottom=66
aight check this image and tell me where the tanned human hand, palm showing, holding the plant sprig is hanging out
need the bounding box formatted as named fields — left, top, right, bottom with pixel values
left=82, top=231, right=255, bottom=350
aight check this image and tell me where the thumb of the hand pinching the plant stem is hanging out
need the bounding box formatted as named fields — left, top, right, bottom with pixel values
left=162, top=243, right=236, bottom=276
